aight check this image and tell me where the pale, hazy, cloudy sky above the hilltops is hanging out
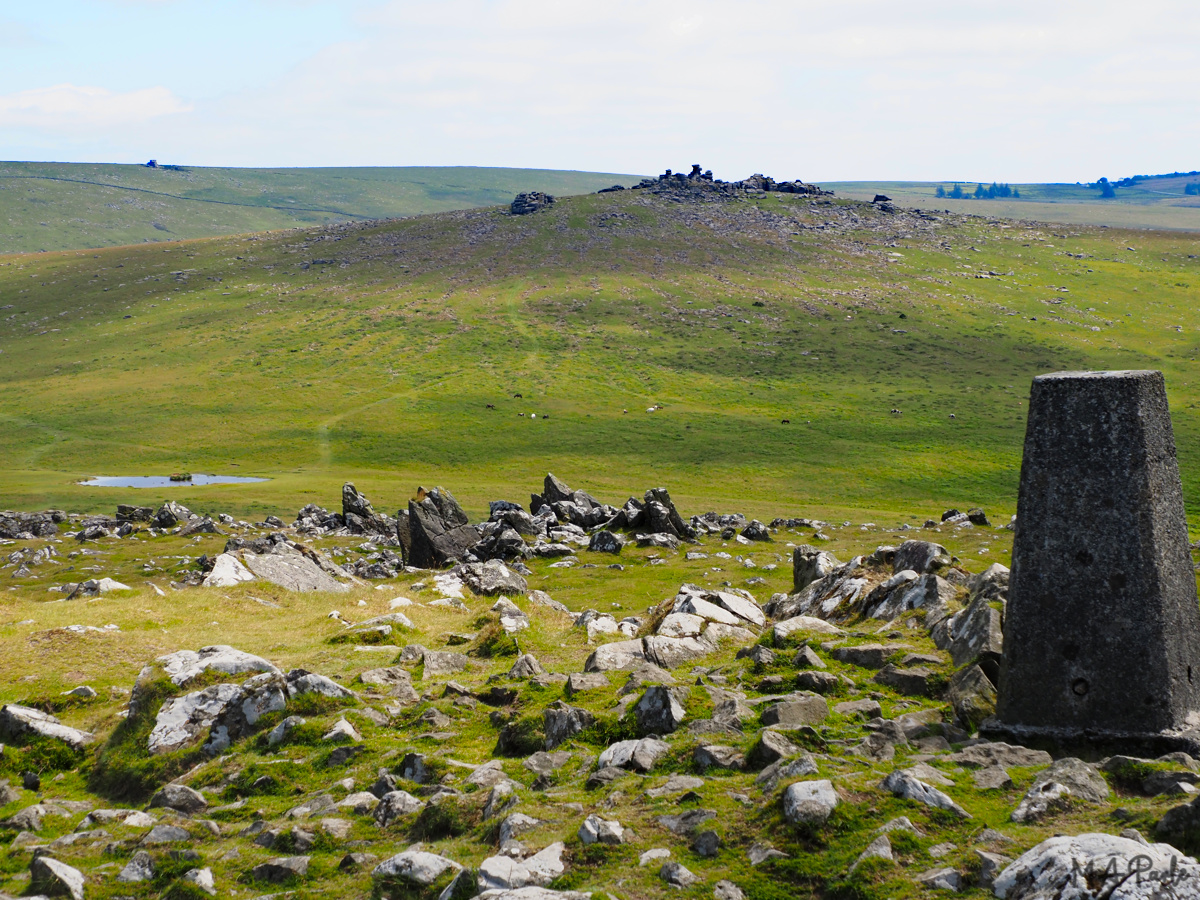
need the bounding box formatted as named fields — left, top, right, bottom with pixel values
left=0, top=0, right=1200, bottom=184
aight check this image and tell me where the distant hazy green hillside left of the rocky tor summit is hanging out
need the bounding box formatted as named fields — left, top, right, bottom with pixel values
left=0, top=162, right=637, bottom=253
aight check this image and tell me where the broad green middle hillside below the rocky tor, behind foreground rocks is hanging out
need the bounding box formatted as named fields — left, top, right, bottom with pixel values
left=0, top=191, right=1200, bottom=532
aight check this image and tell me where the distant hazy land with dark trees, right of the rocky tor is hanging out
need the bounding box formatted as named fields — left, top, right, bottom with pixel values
left=822, top=175, right=1200, bottom=232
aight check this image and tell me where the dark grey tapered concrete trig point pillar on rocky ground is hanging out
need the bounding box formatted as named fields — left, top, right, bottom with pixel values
left=985, top=372, right=1200, bottom=748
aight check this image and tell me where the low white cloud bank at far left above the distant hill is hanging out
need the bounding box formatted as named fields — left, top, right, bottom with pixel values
left=0, top=84, right=191, bottom=132
